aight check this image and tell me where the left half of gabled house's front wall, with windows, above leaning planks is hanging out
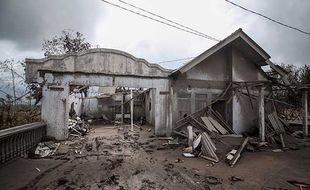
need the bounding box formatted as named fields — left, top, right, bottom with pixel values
left=172, top=49, right=229, bottom=123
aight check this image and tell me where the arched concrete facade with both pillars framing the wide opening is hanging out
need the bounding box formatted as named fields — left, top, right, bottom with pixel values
left=26, top=49, right=172, bottom=140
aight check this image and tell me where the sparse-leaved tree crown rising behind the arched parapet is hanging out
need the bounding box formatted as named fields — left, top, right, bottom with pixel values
left=42, top=30, right=91, bottom=56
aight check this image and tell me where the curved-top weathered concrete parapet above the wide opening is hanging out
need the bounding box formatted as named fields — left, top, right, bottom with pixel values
left=26, top=48, right=172, bottom=82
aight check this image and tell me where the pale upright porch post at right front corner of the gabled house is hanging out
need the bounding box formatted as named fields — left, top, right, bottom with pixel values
left=258, top=86, right=265, bottom=142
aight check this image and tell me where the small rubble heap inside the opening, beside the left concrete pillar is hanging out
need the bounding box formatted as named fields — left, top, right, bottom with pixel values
left=68, top=117, right=91, bottom=137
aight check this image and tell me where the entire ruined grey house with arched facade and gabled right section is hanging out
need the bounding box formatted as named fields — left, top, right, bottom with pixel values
left=26, top=29, right=308, bottom=141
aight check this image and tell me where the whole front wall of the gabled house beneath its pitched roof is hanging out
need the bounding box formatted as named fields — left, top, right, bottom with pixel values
left=172, top=46, right=268, bottom=133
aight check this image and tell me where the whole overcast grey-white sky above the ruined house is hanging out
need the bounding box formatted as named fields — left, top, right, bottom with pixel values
left=0, top=0, right=310, bottom=68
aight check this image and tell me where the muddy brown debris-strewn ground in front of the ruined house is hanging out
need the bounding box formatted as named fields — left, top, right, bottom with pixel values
left=0, top=125, right=310, bottom=190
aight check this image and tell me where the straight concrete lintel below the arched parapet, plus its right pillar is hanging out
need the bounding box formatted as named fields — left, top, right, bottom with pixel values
left=41, top=73, right=172, bottom=136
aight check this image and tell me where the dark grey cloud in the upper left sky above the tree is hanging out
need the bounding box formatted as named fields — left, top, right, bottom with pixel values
left=0, top=0, right=103, bottom=50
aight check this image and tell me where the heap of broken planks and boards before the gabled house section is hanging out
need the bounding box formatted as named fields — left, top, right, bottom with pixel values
left=173, top=104, right=300, bottom=167
